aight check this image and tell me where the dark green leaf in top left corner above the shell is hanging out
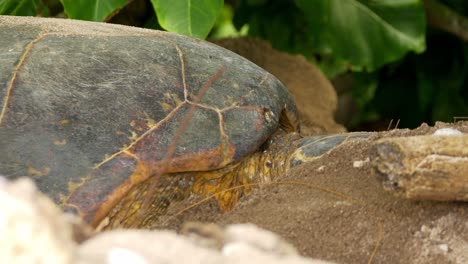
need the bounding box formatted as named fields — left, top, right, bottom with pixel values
left=0, top=0, right=48, bottom=16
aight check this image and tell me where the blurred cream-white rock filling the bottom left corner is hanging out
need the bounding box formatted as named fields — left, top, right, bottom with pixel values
left=0, top=178, right=75, bottom=264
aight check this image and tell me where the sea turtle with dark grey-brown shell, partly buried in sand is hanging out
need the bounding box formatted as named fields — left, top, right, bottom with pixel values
left=0, top=16, right=366, bottom=227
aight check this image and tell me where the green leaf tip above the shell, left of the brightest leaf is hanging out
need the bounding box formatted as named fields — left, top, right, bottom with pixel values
left=60, top=0, right=128, bottom=22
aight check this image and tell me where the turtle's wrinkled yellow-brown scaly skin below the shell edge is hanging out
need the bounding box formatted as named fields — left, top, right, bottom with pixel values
left=98, top=132, right=300, bottom=229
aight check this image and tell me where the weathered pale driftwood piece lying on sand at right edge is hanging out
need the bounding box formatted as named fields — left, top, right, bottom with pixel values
left=370, top=134, right=468, bottom=201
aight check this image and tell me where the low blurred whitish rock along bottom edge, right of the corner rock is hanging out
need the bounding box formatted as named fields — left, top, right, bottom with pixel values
left=78, top=225, right=329, bottom=264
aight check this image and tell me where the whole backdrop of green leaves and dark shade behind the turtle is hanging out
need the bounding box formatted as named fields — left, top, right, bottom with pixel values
left=0, top=0, right=468, bottom=127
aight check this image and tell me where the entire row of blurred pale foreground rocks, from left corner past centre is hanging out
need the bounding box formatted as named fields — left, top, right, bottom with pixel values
left=0, top=177, right=332, bottom=264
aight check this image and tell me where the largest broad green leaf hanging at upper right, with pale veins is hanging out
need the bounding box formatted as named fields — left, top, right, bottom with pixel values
left=295, top=0, right=426, bottom=71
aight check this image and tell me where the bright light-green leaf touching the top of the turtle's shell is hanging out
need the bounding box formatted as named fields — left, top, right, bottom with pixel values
left=151, top=0, right=223, bottom=38
